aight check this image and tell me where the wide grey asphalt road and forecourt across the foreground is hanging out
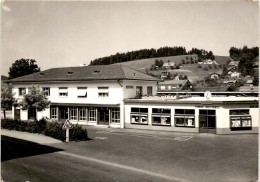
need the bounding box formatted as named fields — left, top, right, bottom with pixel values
left=2, top=128, right=258, bottom=181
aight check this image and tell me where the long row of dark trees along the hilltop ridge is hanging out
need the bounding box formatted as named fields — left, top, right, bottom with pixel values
left=90, top=46, right=214, bottom=65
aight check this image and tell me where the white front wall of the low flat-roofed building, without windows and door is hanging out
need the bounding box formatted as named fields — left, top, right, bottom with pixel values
left=125, top=103, right=259, bottom=134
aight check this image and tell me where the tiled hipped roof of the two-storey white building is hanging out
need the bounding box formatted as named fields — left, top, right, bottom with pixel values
left=8, top=64, right=160, bottom=82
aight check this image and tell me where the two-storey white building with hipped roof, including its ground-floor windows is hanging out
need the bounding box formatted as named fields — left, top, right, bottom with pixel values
left=8, top=64, right=160, bottom=128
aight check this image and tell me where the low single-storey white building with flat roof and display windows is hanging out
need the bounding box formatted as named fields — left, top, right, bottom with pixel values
left=125, top=96, right=259, bottom=134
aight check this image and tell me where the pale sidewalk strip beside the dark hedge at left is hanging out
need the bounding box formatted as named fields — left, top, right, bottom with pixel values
left=1, top=129, right=62, bottom=144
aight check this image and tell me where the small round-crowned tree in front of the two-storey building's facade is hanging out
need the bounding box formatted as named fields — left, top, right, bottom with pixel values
left=19, top=85, right=50, bottom=120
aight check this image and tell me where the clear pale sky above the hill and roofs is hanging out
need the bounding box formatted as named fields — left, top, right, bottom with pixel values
left=1, top=1, right=259, bottom=76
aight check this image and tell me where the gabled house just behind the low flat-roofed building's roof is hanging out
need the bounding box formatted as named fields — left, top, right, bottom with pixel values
left=157, top=80, right=192, bottom=92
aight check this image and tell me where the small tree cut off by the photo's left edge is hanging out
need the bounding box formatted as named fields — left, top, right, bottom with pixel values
left=1, top=85, right=15, bottom=119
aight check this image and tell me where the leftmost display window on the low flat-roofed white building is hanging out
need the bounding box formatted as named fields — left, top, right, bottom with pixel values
left=130, top=107, right=148, bottom=124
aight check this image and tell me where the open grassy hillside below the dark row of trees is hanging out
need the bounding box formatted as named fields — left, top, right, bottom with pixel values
left=116, top=54, right=229, bottom=81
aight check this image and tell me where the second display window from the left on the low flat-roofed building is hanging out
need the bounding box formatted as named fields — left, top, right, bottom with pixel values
left=152, top=108, right=171, bottom=126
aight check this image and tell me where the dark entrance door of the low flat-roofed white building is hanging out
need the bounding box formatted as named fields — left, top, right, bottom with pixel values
left=199, top=109, right=216, bottom=133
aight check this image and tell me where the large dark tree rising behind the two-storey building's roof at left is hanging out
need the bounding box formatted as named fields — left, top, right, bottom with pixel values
left=8, top=59, right=40, bottom=79
